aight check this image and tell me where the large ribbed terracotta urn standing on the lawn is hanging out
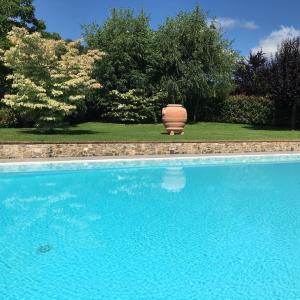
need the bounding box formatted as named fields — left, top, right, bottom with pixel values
left=162, top=104, right=187, bottom=135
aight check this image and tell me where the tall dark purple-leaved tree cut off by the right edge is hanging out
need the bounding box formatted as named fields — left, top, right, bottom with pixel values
left=270, top=37, right=300, bottom=129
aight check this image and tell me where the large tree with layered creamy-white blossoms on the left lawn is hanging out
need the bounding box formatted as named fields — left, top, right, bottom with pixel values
left=1, top=27, right=104, bottom=129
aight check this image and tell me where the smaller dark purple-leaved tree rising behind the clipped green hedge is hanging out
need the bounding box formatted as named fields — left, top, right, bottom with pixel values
left=234, top=50, right=270, bottom=96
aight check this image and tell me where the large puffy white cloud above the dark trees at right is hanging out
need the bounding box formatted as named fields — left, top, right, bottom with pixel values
left=252, top=26, right=300, bottom=56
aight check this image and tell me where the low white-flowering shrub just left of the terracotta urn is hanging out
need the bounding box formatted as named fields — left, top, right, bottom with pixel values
left=102, top=90, right=159, bottom=123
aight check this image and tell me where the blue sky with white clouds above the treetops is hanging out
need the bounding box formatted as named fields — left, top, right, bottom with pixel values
left=34, top=0, right=300, bottom=55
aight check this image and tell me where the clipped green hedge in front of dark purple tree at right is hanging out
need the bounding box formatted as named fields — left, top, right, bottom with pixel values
left=219, top=95, right=274, bottom=125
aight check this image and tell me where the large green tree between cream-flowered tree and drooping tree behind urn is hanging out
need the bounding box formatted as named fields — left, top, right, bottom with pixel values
left=84, top=9, right=157, bottom=122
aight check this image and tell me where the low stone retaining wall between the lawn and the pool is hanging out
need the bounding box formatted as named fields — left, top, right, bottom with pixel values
left=0, top=141, right=300, bottom=159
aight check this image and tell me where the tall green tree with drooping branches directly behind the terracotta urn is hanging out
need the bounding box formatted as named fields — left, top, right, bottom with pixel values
left=155, top=6, right=238, bottom=121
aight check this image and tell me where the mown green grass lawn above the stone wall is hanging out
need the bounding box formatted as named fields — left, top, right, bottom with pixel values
left=0, top=122, right=300, bottom=142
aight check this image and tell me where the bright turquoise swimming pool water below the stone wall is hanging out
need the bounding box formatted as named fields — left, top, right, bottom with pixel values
left=0, top=156, right=300, bottom=300
